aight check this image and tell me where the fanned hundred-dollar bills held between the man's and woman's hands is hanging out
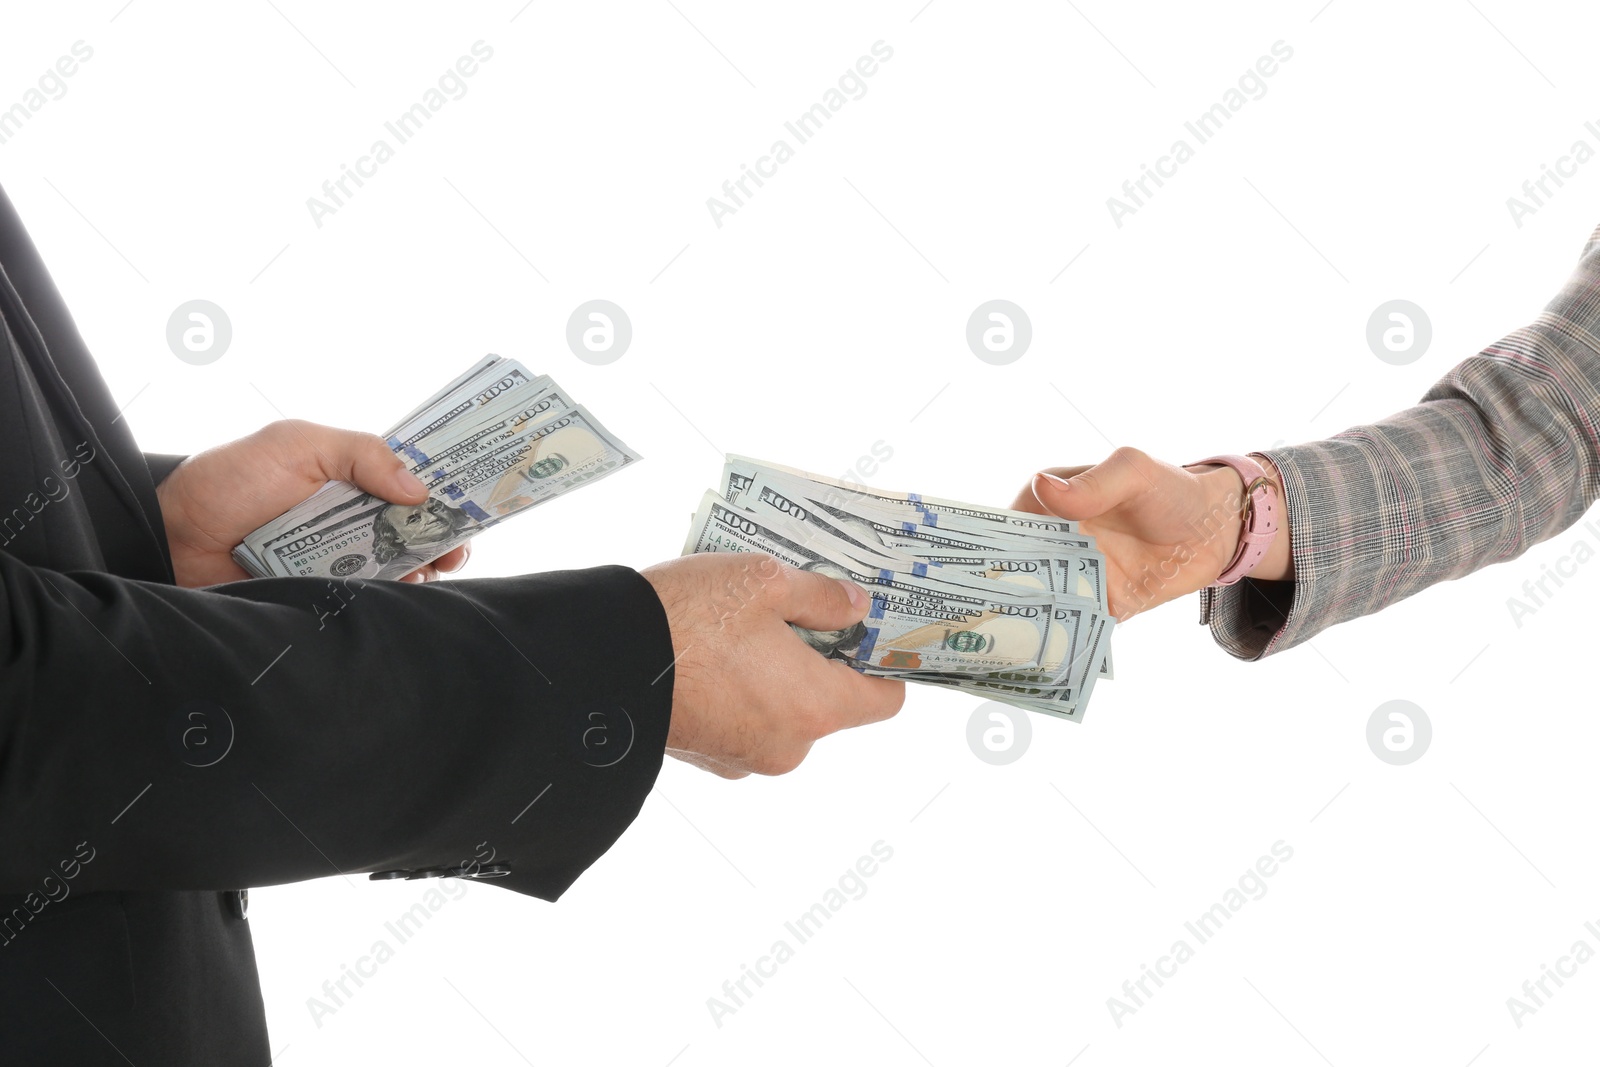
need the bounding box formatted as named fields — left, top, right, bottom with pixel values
left=683, top=456, right=1117, bottom=721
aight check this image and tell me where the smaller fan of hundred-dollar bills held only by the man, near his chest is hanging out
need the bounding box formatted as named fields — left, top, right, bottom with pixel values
left=234, top=355, right=638, bottom=579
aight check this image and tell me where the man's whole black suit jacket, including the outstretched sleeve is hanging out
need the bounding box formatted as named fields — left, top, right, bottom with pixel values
left=0, top=183, right=672, bottom=1067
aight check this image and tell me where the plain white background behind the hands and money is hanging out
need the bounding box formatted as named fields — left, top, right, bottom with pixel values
left=0, top=0, right=1600, bottom=1067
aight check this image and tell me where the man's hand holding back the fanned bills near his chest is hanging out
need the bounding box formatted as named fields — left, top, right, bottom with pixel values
left=155, top=419, right=469, bottom=589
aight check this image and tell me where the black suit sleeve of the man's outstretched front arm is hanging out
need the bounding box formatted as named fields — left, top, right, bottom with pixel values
left=0, top=552, right=674, bottom=901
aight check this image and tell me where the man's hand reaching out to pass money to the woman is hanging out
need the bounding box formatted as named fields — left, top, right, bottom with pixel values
left=643, top=552, right=906, bottom=777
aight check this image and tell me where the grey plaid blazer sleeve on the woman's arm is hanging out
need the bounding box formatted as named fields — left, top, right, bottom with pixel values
left=1200, top=229, right=1600, bottom=659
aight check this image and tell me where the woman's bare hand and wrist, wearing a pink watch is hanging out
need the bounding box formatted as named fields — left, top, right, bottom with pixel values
left=1011, top=448, right=1293, bottom=619
